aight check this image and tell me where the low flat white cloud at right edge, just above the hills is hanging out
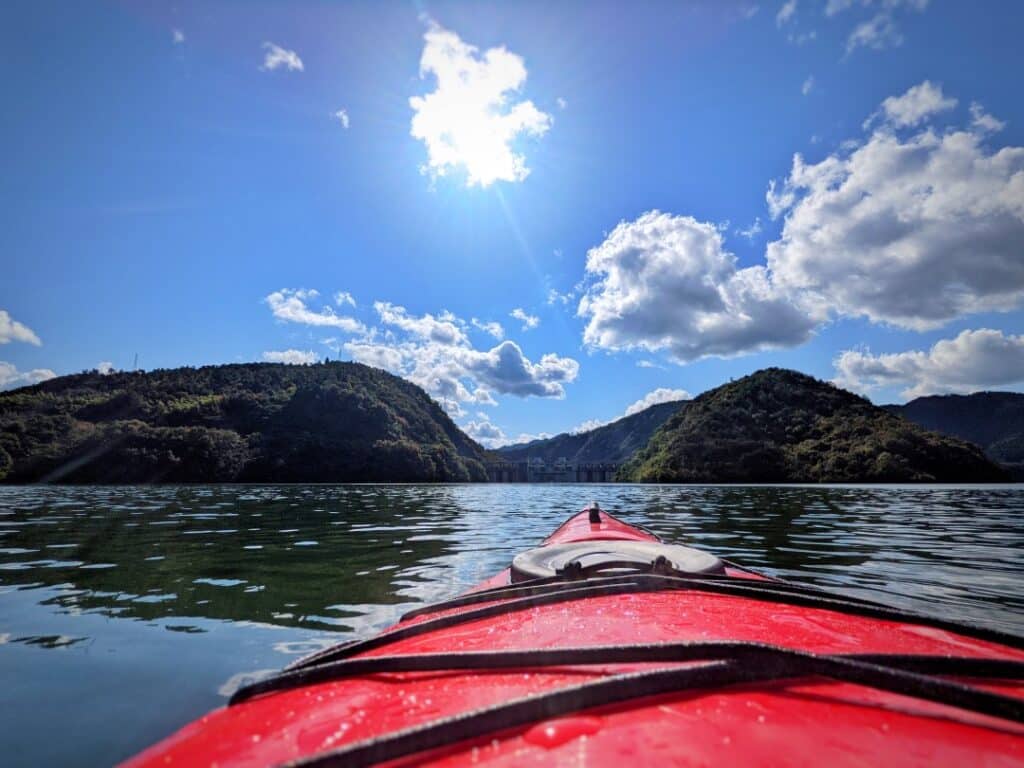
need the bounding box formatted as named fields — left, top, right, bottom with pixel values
left=834, top=329, right=1024, bottom=397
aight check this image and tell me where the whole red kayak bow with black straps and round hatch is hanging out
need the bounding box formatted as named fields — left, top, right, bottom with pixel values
left=128, top=505, right=1024, bottom=768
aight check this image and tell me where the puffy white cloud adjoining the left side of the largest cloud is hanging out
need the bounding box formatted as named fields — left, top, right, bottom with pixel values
left=578, top=211, right=814, bottom=362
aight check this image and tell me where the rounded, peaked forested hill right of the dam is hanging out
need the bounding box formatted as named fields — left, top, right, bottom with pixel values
left=620, top=369, right=1007, bottom=482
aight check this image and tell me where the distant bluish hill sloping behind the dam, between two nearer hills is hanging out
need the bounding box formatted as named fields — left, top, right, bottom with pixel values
left=498, top=400, right=686, bottom=464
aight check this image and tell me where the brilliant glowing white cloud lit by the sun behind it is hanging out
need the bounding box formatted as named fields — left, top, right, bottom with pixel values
left=409, top=22, right=552, bottom=186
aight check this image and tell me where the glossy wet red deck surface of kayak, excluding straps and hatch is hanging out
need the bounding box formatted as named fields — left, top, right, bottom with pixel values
left=123, top=512, right=1024, bottom=766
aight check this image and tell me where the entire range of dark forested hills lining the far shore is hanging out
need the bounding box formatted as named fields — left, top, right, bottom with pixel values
left=6, top=362, right=1024, bottom=483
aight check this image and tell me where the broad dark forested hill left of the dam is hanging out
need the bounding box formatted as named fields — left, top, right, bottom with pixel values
left=0, top=362, right=486, bottom=482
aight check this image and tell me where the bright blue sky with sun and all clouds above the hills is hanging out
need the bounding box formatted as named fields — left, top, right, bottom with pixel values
left=0, top=0, right=1024, bottom=444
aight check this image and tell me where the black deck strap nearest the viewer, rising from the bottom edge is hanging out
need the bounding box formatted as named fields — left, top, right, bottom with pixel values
left=278, top=644, right=1024, bottom=768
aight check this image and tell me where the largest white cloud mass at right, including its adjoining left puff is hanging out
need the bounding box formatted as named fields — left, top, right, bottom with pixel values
left=577, top=81, right=1024, bottom=362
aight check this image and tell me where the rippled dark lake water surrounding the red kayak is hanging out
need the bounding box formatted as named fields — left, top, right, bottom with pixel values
left=0, top=485, right=1024, bottom=766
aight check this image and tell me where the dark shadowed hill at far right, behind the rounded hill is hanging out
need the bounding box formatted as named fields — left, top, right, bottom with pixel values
left=884, top=392, right=1024, bottom=475
